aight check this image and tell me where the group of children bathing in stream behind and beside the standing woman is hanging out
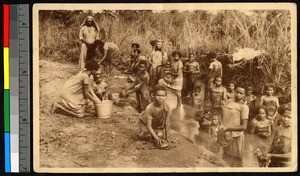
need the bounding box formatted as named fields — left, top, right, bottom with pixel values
left=203, top=79, right=281, bottom=138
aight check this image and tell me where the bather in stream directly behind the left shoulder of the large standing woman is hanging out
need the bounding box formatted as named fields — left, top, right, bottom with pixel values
left=210, top=76, right=227, bottom=111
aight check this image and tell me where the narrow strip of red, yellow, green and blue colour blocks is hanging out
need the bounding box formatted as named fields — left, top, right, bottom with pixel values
left=3, top=5, right=11, bottom=172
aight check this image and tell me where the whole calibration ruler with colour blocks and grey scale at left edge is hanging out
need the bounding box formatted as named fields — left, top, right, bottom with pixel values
left=3, top=4, right=30, bottom=173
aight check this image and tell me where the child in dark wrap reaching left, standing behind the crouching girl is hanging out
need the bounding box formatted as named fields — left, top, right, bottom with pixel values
left=123, top=60, right=150, bottom=112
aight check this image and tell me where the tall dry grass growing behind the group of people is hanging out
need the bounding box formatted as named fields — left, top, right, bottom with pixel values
left=39, top=10, right=291, bottom=101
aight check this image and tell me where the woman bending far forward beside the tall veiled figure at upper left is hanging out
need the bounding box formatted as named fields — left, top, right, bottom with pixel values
left=96, top=40, right=120, bottom=76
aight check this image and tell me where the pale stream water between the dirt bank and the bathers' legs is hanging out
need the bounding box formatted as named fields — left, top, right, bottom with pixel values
left=171, top=104, right=271, bottom=167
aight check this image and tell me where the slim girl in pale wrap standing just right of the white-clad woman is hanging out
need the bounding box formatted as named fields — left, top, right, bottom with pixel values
left=171, top=51, right=183, bottom=97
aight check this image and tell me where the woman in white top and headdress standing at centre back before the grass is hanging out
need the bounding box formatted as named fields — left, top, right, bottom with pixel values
left=149, top=40, right=168, bottom=87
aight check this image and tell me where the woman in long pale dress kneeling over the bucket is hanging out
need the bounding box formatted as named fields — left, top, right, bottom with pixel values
left=51, top=62, right=101, bottom=118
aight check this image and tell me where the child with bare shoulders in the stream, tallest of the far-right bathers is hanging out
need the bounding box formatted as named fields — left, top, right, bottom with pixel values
left=260, top=84, right=279, bottom=127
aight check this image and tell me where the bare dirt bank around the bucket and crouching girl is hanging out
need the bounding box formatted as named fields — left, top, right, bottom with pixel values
left=39, top=60, right=228, bottom=168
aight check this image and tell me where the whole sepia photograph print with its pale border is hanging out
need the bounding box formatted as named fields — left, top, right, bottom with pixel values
left=33, top=3, right=298, bottom=173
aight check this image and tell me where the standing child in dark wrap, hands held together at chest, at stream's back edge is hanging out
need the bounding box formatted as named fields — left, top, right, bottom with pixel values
left=183, top=53, right=200, bottom=100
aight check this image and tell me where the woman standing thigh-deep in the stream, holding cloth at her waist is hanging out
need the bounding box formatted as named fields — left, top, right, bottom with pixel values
left=218, top=85, right=249, bottom=166
